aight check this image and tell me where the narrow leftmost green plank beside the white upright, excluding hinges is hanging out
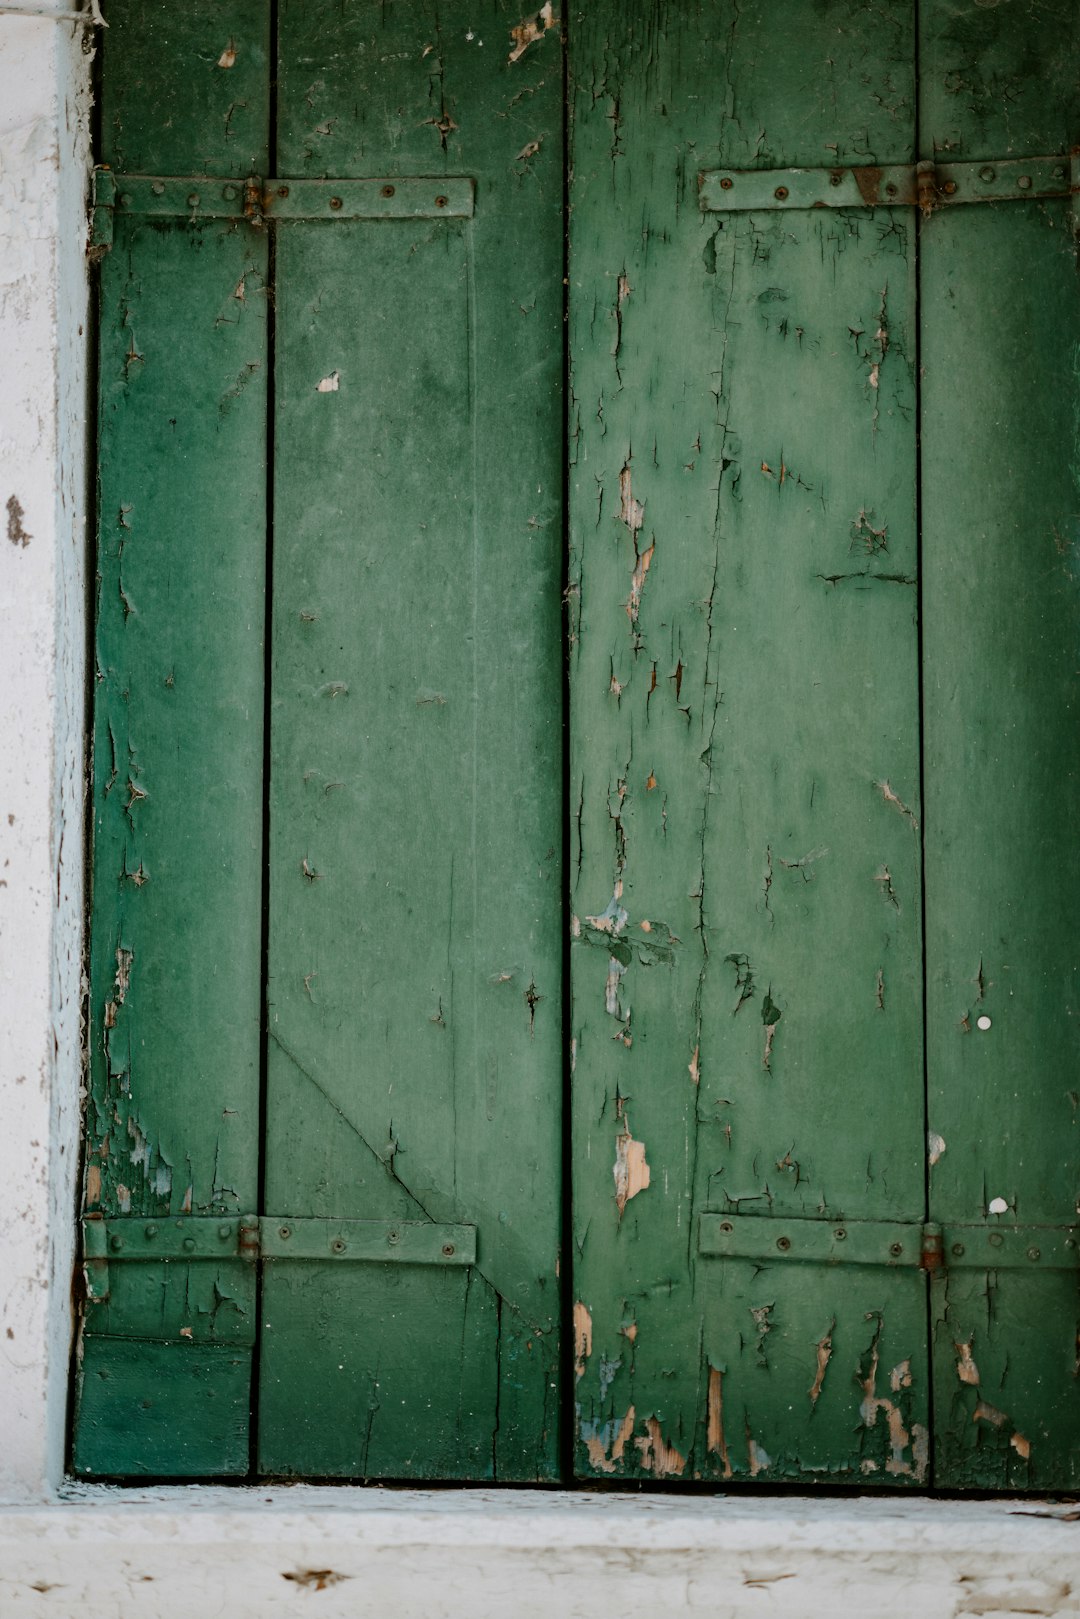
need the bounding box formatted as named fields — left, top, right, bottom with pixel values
left=74, top=0, right=269, bottom=1475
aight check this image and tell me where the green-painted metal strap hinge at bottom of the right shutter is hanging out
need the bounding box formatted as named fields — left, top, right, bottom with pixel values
left=698, top=1214, right=1080, bottom=1274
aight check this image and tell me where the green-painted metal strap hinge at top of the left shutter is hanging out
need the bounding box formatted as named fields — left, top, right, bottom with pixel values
left=89, top=167, right=476, bottom=257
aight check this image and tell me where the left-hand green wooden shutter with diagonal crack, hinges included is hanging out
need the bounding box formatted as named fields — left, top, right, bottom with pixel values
left=74, top=0, right=563, bottom=1480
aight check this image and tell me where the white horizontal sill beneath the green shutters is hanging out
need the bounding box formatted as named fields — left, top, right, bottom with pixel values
left=0, top=1485, right=1080, bottom=1619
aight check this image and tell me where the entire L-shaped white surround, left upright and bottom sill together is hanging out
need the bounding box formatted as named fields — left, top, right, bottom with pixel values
left=0, top=0, right=1080, bottom=1619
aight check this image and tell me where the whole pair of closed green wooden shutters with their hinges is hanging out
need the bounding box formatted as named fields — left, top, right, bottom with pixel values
left=74, top=0, right=1080, bottom=1488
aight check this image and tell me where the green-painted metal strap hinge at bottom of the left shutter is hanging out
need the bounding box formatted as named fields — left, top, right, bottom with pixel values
left=83, top=1214, right=476, bottom=1302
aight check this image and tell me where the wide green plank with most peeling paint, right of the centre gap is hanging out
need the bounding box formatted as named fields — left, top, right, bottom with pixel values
left=570, top=0, right=928, bottom=1485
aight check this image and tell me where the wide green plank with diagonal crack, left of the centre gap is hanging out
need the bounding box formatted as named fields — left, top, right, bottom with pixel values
left=259, top=0, right=562, bottom=1480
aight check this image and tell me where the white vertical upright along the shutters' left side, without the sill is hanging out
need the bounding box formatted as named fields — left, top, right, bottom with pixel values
left=0, top=3, right=87, bottom=1496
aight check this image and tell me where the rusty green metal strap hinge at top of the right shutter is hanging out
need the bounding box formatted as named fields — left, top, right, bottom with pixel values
left=698, top=151, right=1080, bottom=215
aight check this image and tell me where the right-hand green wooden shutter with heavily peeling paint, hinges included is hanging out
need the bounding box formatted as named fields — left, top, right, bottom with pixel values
left=570, top=0, right=1080, bottom=1488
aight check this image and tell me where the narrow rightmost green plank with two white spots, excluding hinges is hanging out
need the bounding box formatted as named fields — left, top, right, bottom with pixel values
left=920, top=0, right=1080, bottom=1489
